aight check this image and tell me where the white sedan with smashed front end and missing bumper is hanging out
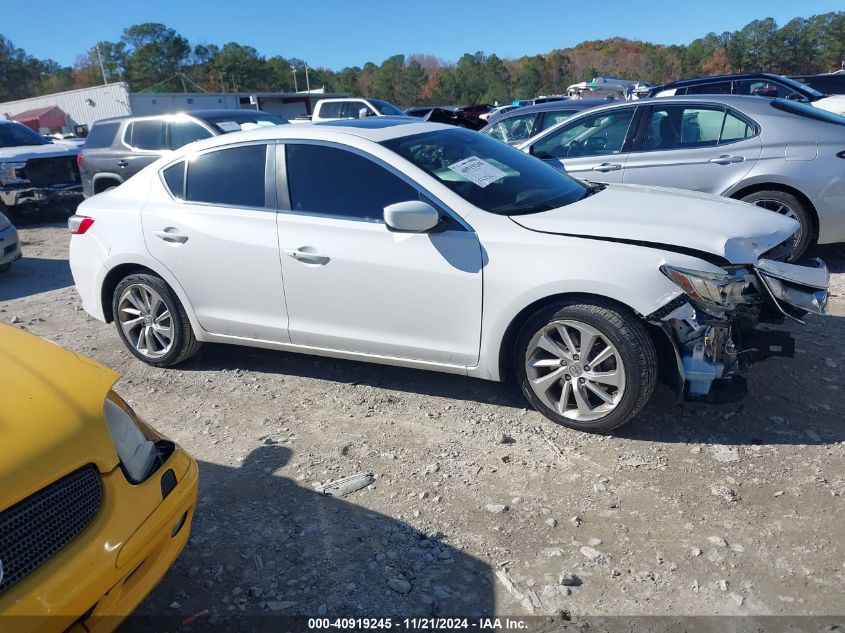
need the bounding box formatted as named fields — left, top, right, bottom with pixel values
left=70, top=118, right=828, bottom=431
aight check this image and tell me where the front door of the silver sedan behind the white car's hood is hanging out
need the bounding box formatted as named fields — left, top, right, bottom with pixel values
left=528, top=106, right=637, bottom=182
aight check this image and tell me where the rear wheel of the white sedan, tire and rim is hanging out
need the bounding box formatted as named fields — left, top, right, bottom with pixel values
left=112, top=274, right=201, bottom=367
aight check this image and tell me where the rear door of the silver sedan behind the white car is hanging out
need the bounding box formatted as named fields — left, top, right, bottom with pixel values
left=622, top=104, right=762, bottom=195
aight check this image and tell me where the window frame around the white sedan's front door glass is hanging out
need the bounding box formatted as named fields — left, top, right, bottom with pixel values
left=275, top=139, right=475, bottom=233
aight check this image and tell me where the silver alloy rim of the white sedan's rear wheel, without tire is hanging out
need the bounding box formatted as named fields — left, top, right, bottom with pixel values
left=117, top=284, right=173, bottom=358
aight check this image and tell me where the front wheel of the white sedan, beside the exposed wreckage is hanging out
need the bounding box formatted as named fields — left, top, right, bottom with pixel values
left=514, top=300, right=657, bottom=432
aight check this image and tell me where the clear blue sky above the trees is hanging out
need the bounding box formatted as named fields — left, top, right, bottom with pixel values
left=6, top=0, right=845, bottom=70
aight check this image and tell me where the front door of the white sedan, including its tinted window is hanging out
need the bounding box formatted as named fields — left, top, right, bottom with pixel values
left=277, top=142, right=482, bottom=366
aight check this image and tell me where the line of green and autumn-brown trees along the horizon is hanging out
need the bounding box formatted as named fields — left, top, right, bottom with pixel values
left=0, top=11, right=845, bottom=107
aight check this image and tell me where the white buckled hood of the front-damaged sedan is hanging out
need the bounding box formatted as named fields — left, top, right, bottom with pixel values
left=511, top=185, right=799, bottom=264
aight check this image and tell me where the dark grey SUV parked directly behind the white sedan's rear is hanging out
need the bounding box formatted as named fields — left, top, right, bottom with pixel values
left=78, top=109, right=287, bottom=198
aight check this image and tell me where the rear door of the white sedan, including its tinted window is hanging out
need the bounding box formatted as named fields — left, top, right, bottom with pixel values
left=142, top=143, right=289, bottom=342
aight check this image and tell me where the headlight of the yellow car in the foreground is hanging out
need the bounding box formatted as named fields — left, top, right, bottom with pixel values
left=103, top=391, right=159, bottom=484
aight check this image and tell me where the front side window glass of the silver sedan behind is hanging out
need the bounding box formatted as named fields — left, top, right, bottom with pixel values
left=531, top=108, right=634, bottom=160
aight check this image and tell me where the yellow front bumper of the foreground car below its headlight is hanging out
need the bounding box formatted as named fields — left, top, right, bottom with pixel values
left=0, top=448, right=199, bottom=633
